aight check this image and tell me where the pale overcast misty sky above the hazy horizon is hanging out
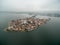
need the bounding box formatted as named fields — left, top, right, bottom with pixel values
left=0, top=0, right=60, bottom=11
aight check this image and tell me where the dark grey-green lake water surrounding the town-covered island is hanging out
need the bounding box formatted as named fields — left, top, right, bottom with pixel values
left=0, top=14, right=60, bottom=45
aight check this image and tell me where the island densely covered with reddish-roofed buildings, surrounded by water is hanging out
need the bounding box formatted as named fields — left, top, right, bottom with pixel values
left=5, top=16, right=50, bottom=32
